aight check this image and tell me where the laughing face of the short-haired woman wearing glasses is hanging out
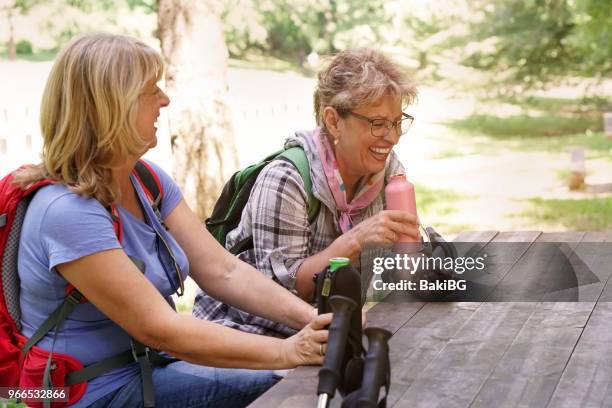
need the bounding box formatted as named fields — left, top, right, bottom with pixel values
left=325, top=93, right=402, bottom=188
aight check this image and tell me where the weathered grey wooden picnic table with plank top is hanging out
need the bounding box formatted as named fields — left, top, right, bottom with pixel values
left=251, top=231, right=612, bottom=408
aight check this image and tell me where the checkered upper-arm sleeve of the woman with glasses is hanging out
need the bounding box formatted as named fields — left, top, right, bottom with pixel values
left=249, top=160, right=310, bottom=290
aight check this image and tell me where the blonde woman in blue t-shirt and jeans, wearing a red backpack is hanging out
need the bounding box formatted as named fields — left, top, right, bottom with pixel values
left=15, top=34, right=331, bottom=407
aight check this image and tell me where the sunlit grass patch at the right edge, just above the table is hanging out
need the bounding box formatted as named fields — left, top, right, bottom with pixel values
left=521, top=197, right=612, bottom=231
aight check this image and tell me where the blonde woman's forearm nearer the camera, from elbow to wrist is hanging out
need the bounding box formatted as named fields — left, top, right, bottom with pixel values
left=150, top=314, right=292, bottom=369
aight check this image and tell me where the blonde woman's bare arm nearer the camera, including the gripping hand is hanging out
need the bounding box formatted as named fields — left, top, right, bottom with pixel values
left=57, top=249, right=331, bottom=369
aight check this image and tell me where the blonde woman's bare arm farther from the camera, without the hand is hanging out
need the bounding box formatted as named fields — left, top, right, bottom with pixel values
left=165, top=200, right=315, bottom=329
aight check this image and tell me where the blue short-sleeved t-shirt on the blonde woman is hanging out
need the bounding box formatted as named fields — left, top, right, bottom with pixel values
left=18, top=163, right=189, bottom=406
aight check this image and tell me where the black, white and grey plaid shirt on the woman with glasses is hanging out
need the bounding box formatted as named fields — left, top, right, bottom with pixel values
left=193, top=132, right=403, bottom=337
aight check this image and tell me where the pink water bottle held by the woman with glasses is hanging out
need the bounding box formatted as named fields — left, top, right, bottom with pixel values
left=385, top=174, right=420, bottom=252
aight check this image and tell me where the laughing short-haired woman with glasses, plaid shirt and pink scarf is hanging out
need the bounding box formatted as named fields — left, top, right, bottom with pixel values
left=194, top=49, right=419, bottom=337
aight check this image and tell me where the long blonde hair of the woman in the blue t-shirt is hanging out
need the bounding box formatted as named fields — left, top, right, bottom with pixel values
left=15, top=33, right=163, bottom=206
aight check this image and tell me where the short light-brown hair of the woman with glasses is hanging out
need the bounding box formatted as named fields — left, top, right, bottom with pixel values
left=314, top=48, right=417, bottom=129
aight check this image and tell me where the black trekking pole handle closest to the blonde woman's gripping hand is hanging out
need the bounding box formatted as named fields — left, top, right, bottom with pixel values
left=317, top=295, right=357, bottom=408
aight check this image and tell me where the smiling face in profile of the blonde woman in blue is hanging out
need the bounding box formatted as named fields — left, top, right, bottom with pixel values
left=136, top=82, right=170, bottom=149
